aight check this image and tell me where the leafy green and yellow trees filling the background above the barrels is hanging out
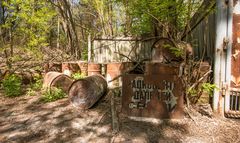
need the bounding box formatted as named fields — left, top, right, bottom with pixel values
left=0, top=0, right=214, bottom=71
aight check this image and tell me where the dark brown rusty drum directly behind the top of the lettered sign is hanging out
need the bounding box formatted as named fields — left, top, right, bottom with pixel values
left=144, top=62, right=179, bottom=75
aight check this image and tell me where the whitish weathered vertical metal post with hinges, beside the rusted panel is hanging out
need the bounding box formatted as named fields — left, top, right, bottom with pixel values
left=213, top=0, right=228, bottom=113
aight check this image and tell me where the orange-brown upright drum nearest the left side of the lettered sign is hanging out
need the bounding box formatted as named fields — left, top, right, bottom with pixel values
left=106, top=62, right=133, bottom=88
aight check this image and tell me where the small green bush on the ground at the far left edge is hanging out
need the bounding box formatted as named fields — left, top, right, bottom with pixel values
left=2, top=74, right=22, bottom=97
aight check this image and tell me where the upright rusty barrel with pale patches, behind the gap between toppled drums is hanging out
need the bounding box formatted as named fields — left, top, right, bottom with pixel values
left=62, top=62, right=81, bottom=76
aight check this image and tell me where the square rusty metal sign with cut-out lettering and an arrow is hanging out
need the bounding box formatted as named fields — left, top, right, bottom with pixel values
left=122, top=74, right=183, bottom=119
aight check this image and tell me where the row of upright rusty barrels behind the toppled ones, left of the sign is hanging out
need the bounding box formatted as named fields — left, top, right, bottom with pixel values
left=44, top=61, right=134, bottom=87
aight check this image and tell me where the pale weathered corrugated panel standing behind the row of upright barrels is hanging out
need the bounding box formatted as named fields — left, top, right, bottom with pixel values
left=92, top=38, right=155, bottom=63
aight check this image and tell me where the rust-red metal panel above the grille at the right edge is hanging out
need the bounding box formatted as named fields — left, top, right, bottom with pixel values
left=231, top=0, right=240, bottom=88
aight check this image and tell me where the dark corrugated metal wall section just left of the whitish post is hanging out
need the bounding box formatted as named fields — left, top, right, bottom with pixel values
left=187, top=13, right=216, bottom=63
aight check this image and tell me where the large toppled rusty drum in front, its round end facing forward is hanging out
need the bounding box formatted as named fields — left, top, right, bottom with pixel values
left=68, top=75, right=107, bottom=109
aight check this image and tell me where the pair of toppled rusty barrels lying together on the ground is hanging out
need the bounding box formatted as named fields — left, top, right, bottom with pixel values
left=43, top=72, right=107, bottom=109
